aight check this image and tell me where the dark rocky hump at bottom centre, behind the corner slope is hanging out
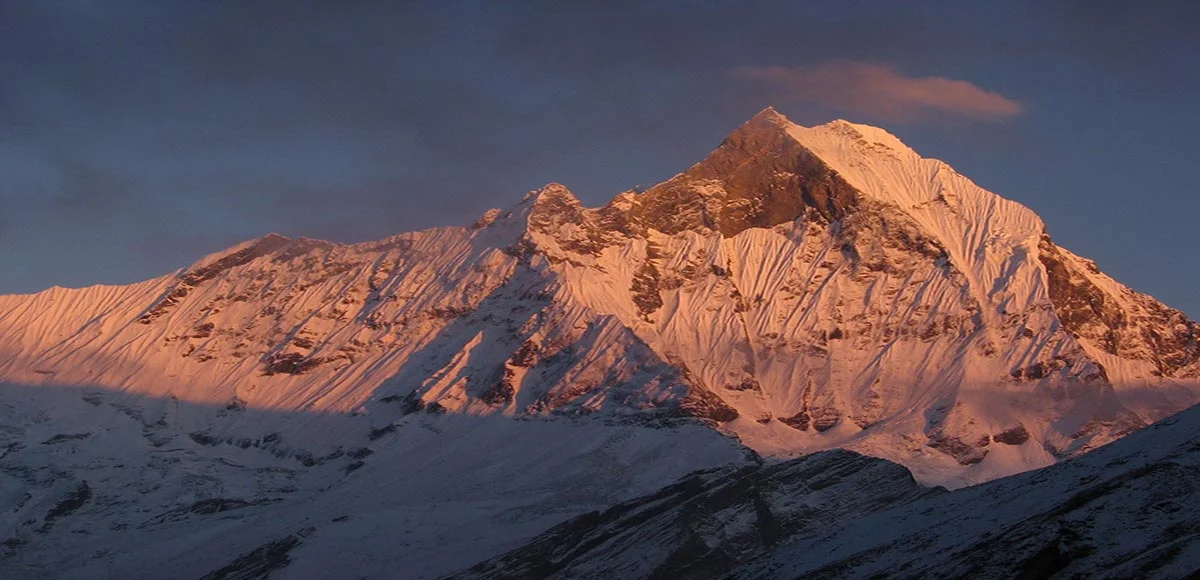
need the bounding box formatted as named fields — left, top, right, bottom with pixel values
left=449, top=450, right=942, bottom=580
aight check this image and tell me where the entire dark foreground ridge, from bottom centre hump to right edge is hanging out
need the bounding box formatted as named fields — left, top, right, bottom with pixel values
left=450, top=407, right=1200, bottom=580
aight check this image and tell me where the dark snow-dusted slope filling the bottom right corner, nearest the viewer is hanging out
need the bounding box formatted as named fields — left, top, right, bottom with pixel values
left=726, top=407, right=1200, bottom=580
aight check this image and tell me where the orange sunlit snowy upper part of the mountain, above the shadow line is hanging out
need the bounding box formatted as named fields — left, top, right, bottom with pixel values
left=0, top=109, right=1200, bottom=485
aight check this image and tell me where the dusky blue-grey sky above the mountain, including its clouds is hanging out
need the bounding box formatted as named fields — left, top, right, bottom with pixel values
left=0, top=0, right=1200, bottom=318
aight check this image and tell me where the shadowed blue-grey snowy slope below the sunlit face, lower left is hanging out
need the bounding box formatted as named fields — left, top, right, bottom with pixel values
left=0, top=384, right=750, bottom=579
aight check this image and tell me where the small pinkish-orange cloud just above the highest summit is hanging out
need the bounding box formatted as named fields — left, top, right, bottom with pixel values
left=736, top=61, right=1024, bottom=122
